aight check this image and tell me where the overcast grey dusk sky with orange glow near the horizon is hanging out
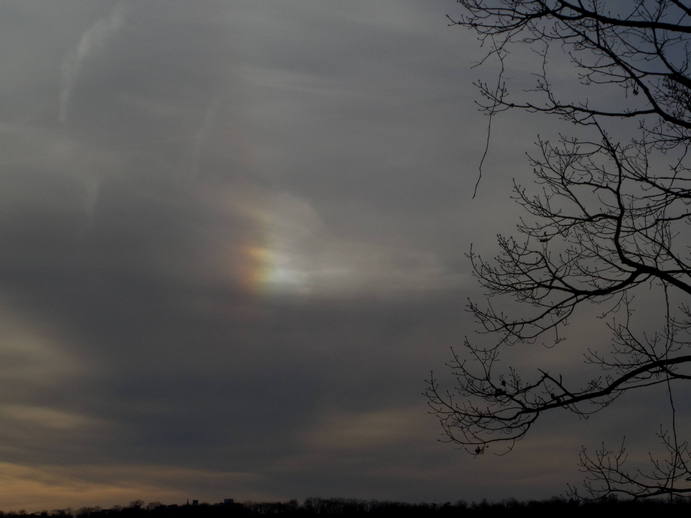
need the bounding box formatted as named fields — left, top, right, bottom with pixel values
left=0, top=0, right=684, bottom=510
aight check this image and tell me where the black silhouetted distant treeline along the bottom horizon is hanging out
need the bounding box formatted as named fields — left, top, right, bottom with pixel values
left=5, top=498, right=691, bottom=518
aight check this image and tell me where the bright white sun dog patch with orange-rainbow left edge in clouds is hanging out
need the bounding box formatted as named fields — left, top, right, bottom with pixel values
left=230, top=194, right=461, bottom=296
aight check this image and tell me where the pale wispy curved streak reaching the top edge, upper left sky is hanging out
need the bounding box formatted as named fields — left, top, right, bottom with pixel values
left=58, top=2, right=125, bottom=123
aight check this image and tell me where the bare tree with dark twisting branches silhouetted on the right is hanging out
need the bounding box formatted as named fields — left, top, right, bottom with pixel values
left=426, top=0, right=691, bottom=504
